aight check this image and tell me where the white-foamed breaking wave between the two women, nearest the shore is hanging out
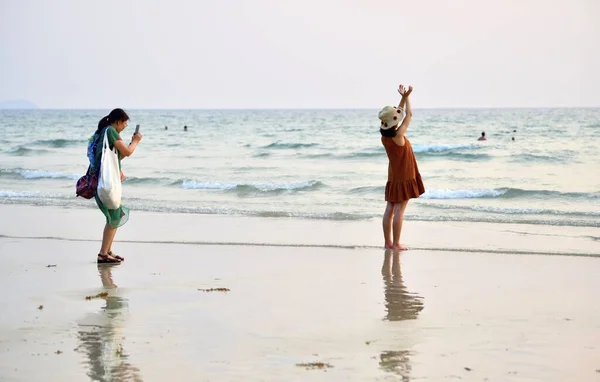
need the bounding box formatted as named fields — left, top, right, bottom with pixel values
left=181, top=180, right=324, bottom=195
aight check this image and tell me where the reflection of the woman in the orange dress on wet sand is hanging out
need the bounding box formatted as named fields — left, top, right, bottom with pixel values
left=379, top=250, right=424, bottom=381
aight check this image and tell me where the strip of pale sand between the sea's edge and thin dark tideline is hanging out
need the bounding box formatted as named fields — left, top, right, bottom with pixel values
left=0, top=205, right=600, bottom=257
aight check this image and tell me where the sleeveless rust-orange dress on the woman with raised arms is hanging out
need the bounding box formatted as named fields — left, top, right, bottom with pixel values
left=381, top=137, right=425, bottom=203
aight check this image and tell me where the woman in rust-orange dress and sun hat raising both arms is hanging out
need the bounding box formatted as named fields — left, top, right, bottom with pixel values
left=379, top=85, right=425, bottom=250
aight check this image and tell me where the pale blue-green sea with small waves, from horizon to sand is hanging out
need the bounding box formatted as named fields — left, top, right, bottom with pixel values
left=0, top=108, right=600, bottom=227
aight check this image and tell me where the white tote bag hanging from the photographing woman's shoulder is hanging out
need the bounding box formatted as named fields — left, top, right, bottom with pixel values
left=97, top=128, right=121, bottom=210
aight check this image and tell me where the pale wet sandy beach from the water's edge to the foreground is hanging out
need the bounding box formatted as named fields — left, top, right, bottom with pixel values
left=0, top=205, right=600, bottom=381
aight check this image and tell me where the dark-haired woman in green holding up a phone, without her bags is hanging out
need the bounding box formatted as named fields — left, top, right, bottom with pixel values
left=88, top=109, right=142, bottom=264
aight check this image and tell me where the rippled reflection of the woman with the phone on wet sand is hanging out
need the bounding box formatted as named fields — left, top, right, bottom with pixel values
left=77, top=264, right=142, bottom=381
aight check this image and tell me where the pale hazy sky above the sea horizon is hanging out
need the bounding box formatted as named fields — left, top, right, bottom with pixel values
left=0, top=0, right=600, bottom=109
